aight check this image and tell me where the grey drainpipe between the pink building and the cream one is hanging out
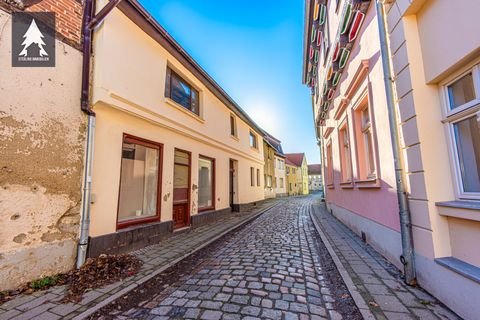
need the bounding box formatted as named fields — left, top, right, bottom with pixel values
left=376, top=0, right=416, bottom=285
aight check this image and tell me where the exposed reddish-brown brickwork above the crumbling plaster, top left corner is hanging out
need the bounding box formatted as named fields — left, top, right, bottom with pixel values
left=0, top=0, right=84, bottom=49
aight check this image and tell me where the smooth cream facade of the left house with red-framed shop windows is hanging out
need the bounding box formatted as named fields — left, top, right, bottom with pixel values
left=90, top=3, right=264, bottom=248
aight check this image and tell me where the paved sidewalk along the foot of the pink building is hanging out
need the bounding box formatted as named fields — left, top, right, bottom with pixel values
left=311, top=199, right=460, bottom=320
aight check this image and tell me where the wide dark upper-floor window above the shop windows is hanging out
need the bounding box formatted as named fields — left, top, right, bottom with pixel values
left=165, top=67, right=200, bottom=115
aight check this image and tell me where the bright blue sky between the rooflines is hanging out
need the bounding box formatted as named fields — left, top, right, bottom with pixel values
left=140, top=0, right=320, bottom=163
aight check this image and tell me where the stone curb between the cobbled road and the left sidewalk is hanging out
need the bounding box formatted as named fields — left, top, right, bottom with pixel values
left=73, top=201, right=281, bottom=320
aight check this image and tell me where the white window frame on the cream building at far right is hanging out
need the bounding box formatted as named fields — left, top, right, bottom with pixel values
left=442, top=62, right=480, bottom=200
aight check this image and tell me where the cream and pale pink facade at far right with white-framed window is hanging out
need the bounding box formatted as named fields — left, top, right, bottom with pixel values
left=387, top=0, right=480, bottom=319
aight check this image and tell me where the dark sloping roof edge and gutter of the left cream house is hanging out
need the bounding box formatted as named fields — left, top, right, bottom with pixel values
left=117, top=0, right=264, bottom=134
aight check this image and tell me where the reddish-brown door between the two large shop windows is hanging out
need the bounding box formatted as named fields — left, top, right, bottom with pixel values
left=173, top=150, right=190, bottom=229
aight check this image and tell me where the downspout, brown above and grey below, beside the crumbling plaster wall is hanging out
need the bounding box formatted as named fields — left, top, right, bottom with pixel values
left=76, top=0, right=121, bottom=268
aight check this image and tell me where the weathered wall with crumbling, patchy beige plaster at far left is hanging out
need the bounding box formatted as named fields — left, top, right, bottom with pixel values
left=0, top=2, right=85, bottom=291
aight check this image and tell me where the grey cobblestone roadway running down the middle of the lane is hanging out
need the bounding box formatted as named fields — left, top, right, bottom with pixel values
left=116, top=198, right=361, bottom=320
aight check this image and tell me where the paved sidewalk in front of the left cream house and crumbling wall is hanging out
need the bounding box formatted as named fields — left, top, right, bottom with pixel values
left=0, top=200, right=281, bottom=320
